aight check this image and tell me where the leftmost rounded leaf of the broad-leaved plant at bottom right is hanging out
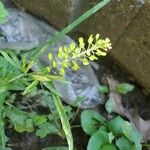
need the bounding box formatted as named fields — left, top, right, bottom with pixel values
left=81, top=109, right=105, bottom=135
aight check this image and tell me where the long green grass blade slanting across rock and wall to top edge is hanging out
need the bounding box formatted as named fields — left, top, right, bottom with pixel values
left=31, top=0, right=111, bottom=59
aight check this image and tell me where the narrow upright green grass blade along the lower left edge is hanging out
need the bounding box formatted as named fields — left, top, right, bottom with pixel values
left=0, top=93, right=6, bottom=150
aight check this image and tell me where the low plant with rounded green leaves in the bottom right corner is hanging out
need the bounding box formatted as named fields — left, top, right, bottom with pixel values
left=81, top=109, right=141, bottom=150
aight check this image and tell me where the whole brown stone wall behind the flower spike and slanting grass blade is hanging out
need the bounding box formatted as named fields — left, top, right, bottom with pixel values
left=14, top=0, right=150, bottom=93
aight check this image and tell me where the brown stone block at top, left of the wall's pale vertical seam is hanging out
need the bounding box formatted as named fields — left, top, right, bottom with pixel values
left=14, top=0, right=71, bottom=29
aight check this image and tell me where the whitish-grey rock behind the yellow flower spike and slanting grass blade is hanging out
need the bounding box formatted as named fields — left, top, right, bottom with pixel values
left=0, top=9, right=103, bottom=108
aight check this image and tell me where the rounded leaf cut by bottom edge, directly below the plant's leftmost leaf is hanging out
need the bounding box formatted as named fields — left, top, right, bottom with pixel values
left=87, top=128, right=109, bottom=150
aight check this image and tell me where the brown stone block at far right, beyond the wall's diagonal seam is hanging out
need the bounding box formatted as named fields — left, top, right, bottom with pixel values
left=112, top=4, right=150, bottom=93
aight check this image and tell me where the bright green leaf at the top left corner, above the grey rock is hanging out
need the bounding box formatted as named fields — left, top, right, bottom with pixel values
left=0, top=1, right=8, bottom=23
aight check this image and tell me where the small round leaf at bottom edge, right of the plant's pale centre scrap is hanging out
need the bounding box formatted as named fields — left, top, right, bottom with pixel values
left=116, top=137, right=132, bottom=150
